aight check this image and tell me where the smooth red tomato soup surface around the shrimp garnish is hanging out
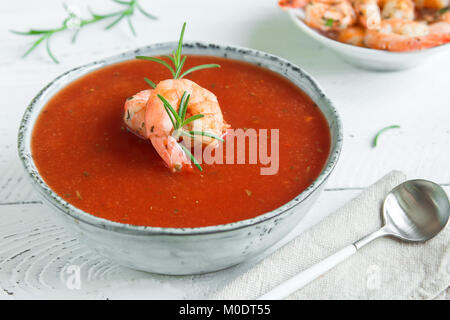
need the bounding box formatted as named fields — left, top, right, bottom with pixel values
left=32, top=56, right=330, bottom=228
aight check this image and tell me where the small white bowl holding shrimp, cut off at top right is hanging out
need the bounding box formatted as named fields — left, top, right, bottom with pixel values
left=288, top=10, right=450, bottom=71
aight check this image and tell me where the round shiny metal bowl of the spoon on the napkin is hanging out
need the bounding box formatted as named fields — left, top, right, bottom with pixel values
left=383, top=179, right=450, bottom=241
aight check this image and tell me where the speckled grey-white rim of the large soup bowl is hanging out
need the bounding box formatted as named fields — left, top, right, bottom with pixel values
left=18, top=41, right=343, bottom=236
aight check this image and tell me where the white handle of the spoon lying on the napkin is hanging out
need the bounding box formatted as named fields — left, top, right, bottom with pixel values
left=258, top=244, right=356, bottom=300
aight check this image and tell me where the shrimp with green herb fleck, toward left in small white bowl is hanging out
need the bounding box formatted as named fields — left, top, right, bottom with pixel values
left=305, top=0, right=356, bottom=31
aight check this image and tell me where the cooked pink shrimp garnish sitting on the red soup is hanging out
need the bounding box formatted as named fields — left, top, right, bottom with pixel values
left=123, top=79, right=229, bottom=172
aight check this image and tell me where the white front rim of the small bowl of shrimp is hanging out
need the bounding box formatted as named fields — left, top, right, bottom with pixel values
left=287, top=9, right=450, bottom=57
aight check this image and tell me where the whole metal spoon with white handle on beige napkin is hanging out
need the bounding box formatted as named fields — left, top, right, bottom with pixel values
left=259, top=180, right=450, bottom=300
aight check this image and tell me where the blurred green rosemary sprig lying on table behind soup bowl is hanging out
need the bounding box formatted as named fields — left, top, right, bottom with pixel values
left=10, top=0, right=157, bottom=63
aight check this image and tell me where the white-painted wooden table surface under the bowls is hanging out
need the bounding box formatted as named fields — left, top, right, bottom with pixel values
left=0, top=0, right=450, bottom=299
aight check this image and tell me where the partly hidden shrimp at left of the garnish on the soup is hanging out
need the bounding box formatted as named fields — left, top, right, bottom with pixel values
left=123, top=90, right=152, bottom=139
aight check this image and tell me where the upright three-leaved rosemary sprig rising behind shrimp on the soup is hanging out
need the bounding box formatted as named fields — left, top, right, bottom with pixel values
left=136, top=22, right=220, bottom=79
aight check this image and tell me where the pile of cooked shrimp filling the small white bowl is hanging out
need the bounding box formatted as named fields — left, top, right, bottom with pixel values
left=278, top=0, right=450, bottom=52
